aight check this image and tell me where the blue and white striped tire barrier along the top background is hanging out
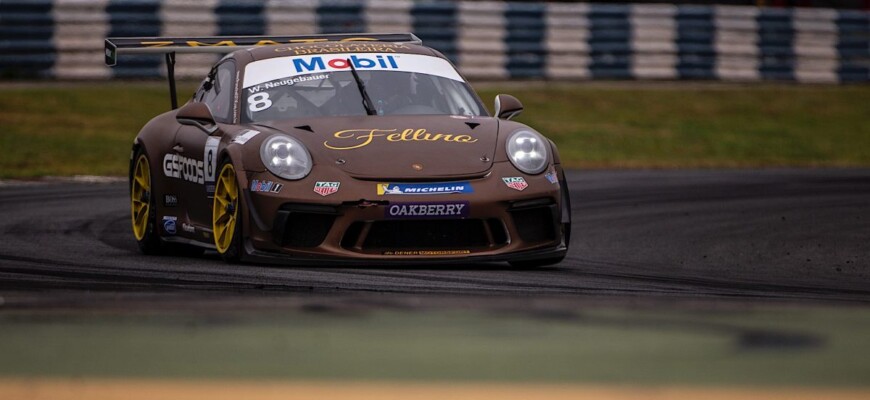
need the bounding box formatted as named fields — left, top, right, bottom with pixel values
left=0, top=0, right=870, bottom=82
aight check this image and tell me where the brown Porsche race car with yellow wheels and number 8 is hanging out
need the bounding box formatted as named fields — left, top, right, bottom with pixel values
left=106, top=34, right=571, bottom=266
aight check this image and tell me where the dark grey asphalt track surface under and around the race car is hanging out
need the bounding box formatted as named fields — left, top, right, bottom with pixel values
left=0, top=169, right=870, bottom=309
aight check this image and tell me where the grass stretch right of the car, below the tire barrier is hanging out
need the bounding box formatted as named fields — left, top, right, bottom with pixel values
left=482, top=84, right=870, bottom=168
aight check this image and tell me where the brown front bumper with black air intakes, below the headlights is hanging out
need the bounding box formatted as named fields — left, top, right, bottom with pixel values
left=243, top=163, right=567, bottom=265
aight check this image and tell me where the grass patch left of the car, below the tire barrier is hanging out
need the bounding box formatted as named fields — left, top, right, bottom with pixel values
left=0, top=83, right=192, bottom=178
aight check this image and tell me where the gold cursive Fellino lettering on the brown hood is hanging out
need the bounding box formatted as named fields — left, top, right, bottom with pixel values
left=323, top=128, right=477, bottom=150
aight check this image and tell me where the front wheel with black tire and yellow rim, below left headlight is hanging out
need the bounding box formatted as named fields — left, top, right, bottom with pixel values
left=212, top=159, right=243, bottom=264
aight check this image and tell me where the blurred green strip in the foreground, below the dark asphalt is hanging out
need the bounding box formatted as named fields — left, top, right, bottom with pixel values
left=0, top=307, right=870, bottom=387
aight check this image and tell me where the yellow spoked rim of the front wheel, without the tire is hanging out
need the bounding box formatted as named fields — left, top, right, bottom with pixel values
left=212, top=164, right=239, bottom=253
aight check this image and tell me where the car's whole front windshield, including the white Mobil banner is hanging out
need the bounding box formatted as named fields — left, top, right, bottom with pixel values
left=241, top=54, right=484, bottom=122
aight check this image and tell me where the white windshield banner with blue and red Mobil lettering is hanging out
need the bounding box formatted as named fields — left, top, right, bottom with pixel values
left=242, top=53, right=464, bottom=88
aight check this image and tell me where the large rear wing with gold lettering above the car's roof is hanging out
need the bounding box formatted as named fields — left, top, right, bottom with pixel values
left=105, top=33, right=423, bottom=109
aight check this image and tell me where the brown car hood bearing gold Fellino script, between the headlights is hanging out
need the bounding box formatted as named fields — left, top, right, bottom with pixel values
left=258, top=115, right=499, bottom=180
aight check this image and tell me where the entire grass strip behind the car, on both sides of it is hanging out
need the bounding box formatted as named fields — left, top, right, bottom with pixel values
left=0, top=82, right=870, bottom=178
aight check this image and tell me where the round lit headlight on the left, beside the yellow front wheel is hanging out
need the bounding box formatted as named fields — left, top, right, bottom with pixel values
left=260, top=135, right=311, bottom=180
